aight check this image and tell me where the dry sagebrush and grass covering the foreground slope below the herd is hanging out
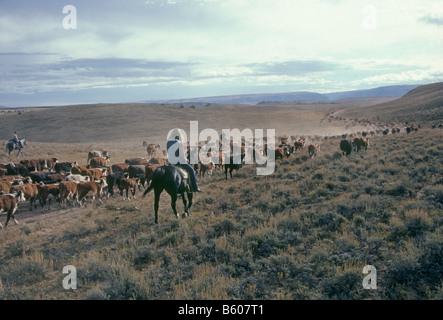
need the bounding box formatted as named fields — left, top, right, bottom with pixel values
left=0, top=84, right=443, bottom=300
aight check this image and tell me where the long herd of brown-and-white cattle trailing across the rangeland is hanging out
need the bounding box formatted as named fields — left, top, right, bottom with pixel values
left=0, top=127, right=426, bottom=229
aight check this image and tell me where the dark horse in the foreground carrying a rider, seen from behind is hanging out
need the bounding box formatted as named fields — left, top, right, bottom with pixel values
left=143, top=166, right=192, bottom=223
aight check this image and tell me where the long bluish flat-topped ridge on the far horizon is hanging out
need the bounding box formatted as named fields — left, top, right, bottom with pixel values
left=141, top=85, right=418, bottom=107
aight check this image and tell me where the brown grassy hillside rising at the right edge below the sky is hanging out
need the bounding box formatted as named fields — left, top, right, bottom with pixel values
left=342, top=82, right=443, bottom=124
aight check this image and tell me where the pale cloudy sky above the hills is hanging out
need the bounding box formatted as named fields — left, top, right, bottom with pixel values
left=0, top=0, right=443, bottom=107
